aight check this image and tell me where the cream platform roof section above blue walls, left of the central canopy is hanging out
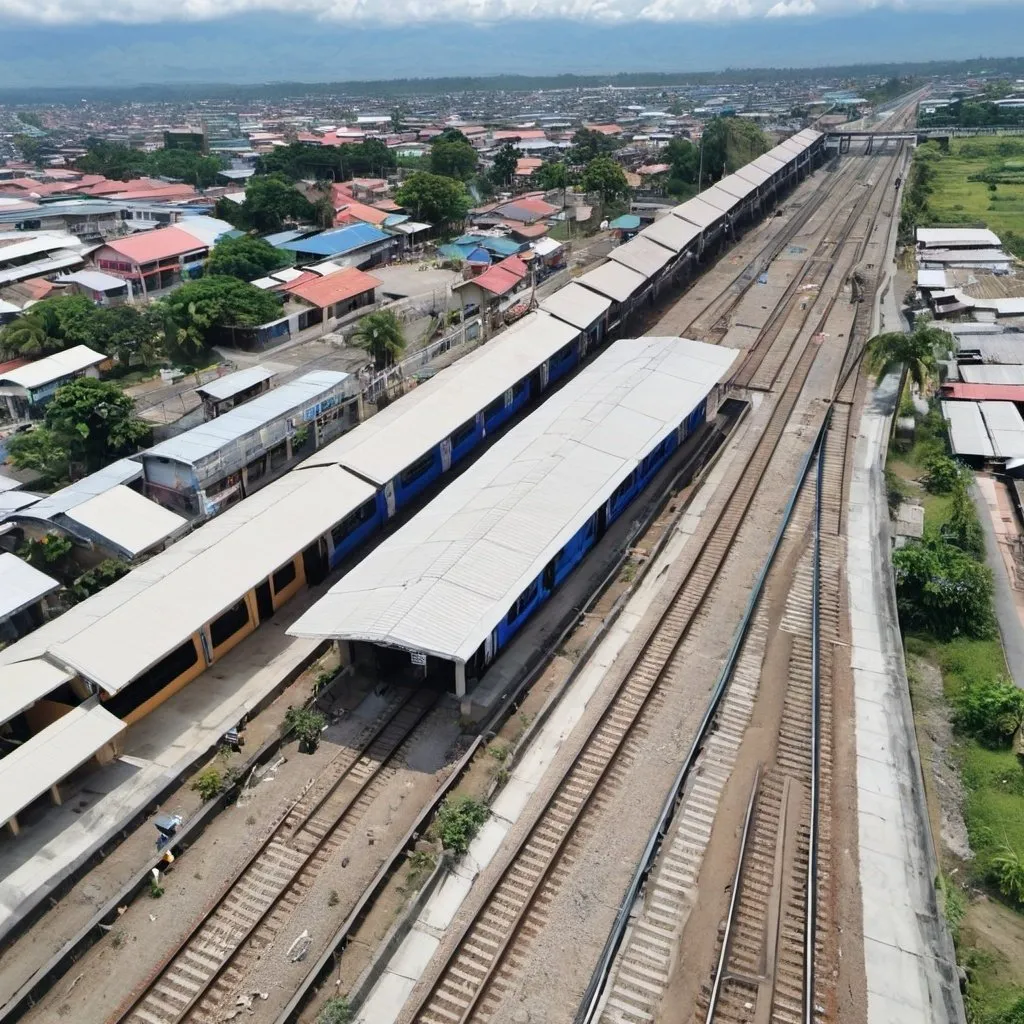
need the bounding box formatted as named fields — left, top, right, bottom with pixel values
left=298, top=312, right=580, bottom=485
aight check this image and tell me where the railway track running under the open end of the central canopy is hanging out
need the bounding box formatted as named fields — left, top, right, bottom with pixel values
left=112, top=689, right=437, bottom=1024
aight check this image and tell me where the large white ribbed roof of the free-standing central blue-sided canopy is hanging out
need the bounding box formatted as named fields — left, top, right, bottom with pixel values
left=289, top=338, right=737, bottom=662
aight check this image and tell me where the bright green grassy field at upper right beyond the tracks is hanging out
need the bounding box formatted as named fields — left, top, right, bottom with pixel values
left=919, top=136, right=1024, bottom=238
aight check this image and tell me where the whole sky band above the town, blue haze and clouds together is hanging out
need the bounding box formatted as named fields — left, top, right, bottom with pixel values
left=0, top=0, right=1024, bottom=88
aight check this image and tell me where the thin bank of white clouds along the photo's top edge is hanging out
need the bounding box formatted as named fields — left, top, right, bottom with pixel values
left=0, top=0, right=1007, bottom=25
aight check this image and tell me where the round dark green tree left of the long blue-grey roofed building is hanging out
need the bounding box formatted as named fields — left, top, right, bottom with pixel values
left=45, top=377, right=150, bottom=473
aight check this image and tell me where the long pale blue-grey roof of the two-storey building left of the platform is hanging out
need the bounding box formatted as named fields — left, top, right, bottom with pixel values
left=143, top=370, right=349, bottom=466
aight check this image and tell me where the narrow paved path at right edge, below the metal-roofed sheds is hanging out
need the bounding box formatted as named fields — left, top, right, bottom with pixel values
left=971, top=473, right=1024, bottom=690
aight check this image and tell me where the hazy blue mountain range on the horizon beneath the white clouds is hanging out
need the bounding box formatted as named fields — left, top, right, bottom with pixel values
left=0, top=4, right=1024, bottom=92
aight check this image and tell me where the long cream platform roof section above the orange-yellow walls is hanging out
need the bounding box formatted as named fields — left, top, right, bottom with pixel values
left=0, top=466, right=375, bottom=693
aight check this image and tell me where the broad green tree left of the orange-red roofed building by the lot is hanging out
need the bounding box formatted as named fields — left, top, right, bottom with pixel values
left=159, top=276, right=282, bottom=355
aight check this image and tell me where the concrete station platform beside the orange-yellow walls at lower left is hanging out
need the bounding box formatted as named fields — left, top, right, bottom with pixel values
left=0, top=588, right=325, bottom=937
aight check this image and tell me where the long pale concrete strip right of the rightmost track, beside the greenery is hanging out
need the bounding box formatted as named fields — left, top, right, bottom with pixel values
left=847, top=375, right=965, bottom=1024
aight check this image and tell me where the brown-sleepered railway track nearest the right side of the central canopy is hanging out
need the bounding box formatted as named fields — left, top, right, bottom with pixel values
left=395, top=140, right=892, bottom=1024
